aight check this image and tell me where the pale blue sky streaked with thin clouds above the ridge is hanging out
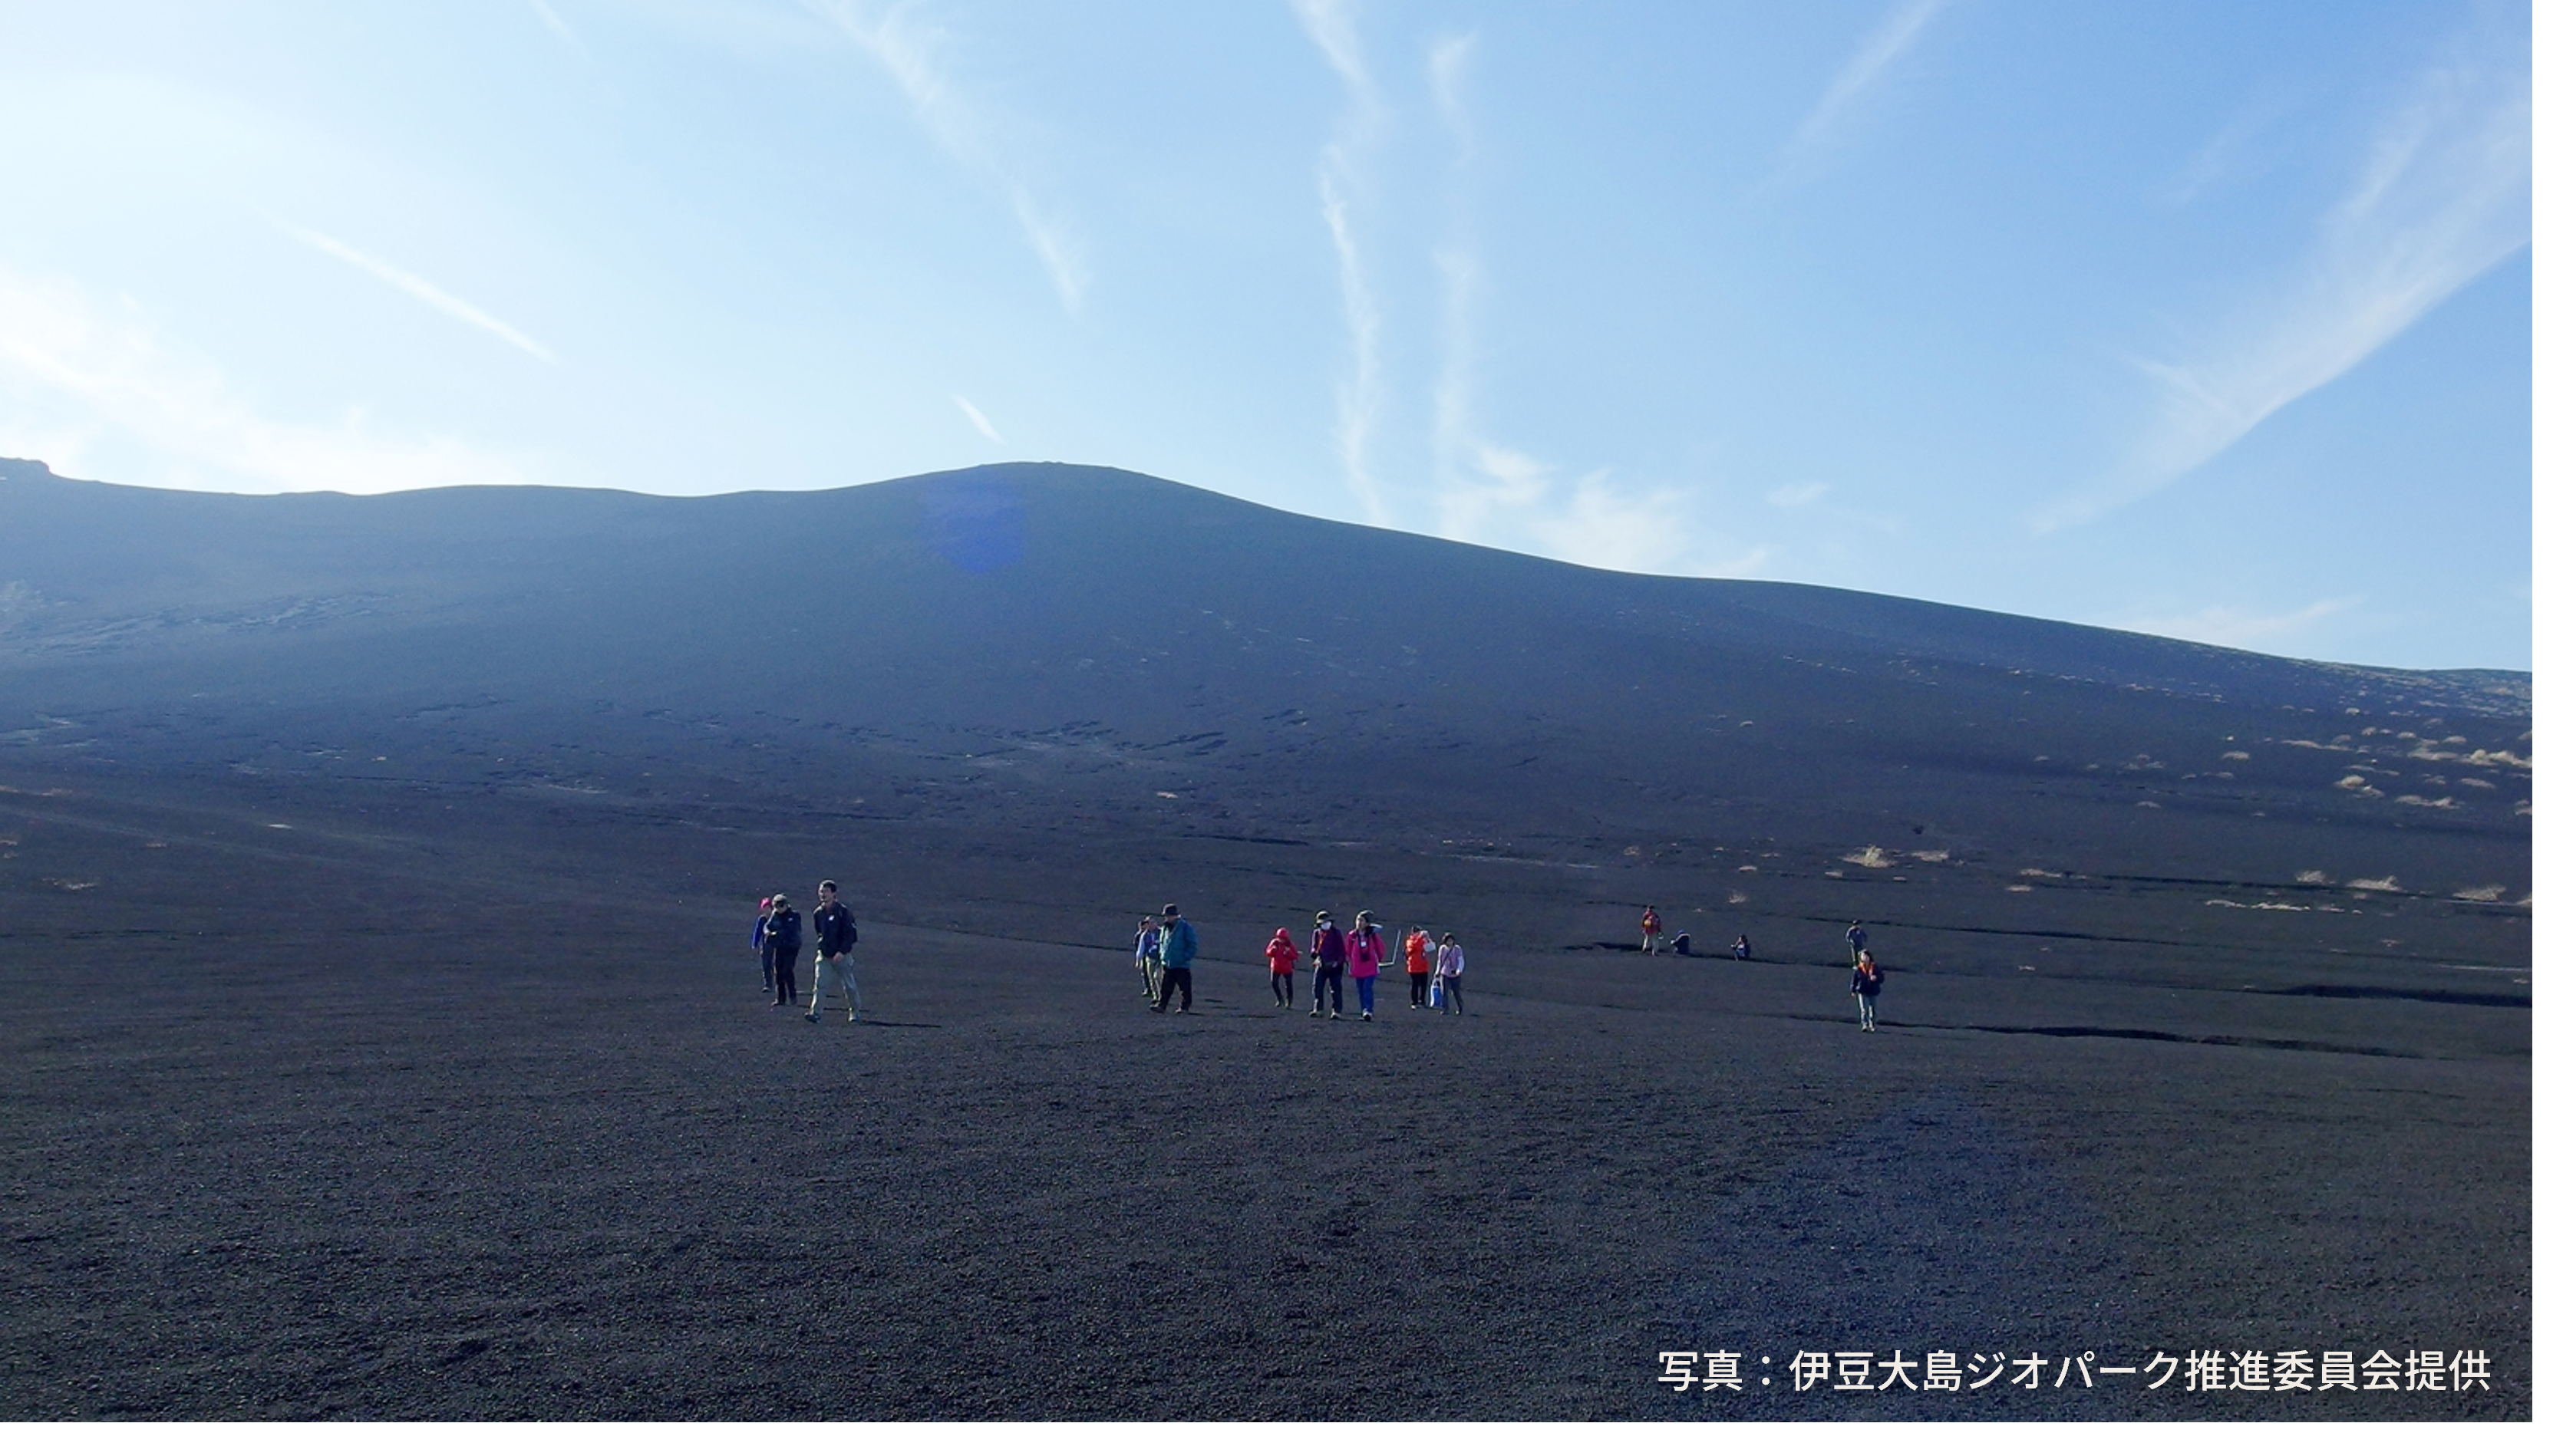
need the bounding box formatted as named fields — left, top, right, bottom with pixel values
left=0, top=0, right=2535, bottom=667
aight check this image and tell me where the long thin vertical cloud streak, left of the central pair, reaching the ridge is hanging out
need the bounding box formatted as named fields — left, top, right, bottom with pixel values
left=1295, top=0, right=1391, bottom=526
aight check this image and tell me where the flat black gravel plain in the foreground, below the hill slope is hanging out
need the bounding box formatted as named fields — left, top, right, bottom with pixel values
left=0, top=776, right=2528, bottom=1415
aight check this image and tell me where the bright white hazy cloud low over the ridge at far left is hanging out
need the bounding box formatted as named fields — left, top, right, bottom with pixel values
left=0, top=265, right=529, bottom=493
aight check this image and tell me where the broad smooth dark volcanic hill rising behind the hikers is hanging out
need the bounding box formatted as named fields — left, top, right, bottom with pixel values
left=0, top=454, right=2522, bottom=894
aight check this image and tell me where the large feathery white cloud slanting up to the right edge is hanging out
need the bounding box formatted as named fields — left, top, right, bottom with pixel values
left=2032, top=19, right=2535, bottom=532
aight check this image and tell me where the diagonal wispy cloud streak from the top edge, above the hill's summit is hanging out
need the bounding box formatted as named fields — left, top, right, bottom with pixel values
left=804, top=0, right=1090, bottom=315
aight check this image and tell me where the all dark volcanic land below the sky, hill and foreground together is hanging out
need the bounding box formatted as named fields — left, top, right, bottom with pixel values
left=0, top=460, right=2530, bottom=1415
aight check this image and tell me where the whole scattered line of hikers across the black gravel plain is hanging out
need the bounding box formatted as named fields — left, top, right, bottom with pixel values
left=753, top=878, right=1887, bottom=1032
